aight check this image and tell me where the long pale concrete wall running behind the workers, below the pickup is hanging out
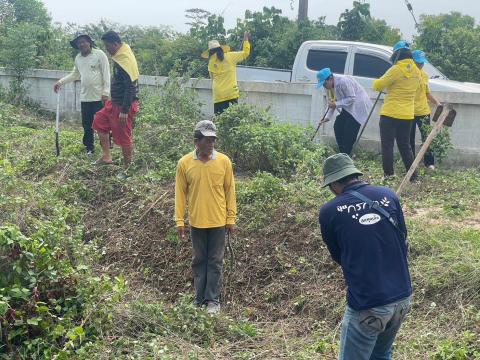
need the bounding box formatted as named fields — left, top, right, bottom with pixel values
left=0, top=69, right=480, bottom=166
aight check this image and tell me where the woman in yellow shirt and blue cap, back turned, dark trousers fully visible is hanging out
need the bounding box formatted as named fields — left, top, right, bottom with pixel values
left=373, top=40, right=420, bottom=181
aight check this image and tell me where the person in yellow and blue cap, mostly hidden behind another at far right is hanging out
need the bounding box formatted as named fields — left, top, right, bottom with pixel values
left=410, top=50, right=440, bottom=170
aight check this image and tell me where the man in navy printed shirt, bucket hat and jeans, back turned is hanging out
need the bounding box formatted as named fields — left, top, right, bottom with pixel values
left=319, top=154, right=412, bottom=360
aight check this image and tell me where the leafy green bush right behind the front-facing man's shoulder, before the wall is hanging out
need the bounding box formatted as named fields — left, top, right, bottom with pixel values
left=215, top=104, right=316, bottom=176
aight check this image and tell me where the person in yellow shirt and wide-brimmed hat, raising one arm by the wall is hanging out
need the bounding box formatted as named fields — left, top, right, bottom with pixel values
left=202, top=31, right=250, bottom=114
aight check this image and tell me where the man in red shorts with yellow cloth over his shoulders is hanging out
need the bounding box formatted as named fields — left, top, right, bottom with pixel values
left=92, top=31, right=139, bottom=180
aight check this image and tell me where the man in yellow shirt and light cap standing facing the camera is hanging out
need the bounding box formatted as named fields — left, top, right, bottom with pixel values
left=175, top=120, right=237, bottom=314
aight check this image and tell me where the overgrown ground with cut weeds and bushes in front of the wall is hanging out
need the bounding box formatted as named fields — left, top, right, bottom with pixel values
left=0, top=80, right=480, bottom=360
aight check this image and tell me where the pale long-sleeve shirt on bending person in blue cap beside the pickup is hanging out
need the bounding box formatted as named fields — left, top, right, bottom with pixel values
left=325, top=74, right=372, bottom=125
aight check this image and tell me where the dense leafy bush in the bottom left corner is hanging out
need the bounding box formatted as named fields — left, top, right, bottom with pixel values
left=0, top=222, right=123, bottom=359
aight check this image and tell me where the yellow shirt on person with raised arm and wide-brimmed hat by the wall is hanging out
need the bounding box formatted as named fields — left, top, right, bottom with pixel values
left=208, top=41, right=250, bottom=103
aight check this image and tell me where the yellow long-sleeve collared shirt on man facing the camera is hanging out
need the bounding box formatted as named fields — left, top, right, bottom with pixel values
left=175, top=151, right=237, bottom=228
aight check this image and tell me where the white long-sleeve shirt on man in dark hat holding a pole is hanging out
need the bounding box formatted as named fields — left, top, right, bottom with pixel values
left=59, top=48, right=110, bottom=102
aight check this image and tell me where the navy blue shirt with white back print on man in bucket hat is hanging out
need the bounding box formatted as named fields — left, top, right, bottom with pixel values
left=319, top=182, right=412, bottom=310
